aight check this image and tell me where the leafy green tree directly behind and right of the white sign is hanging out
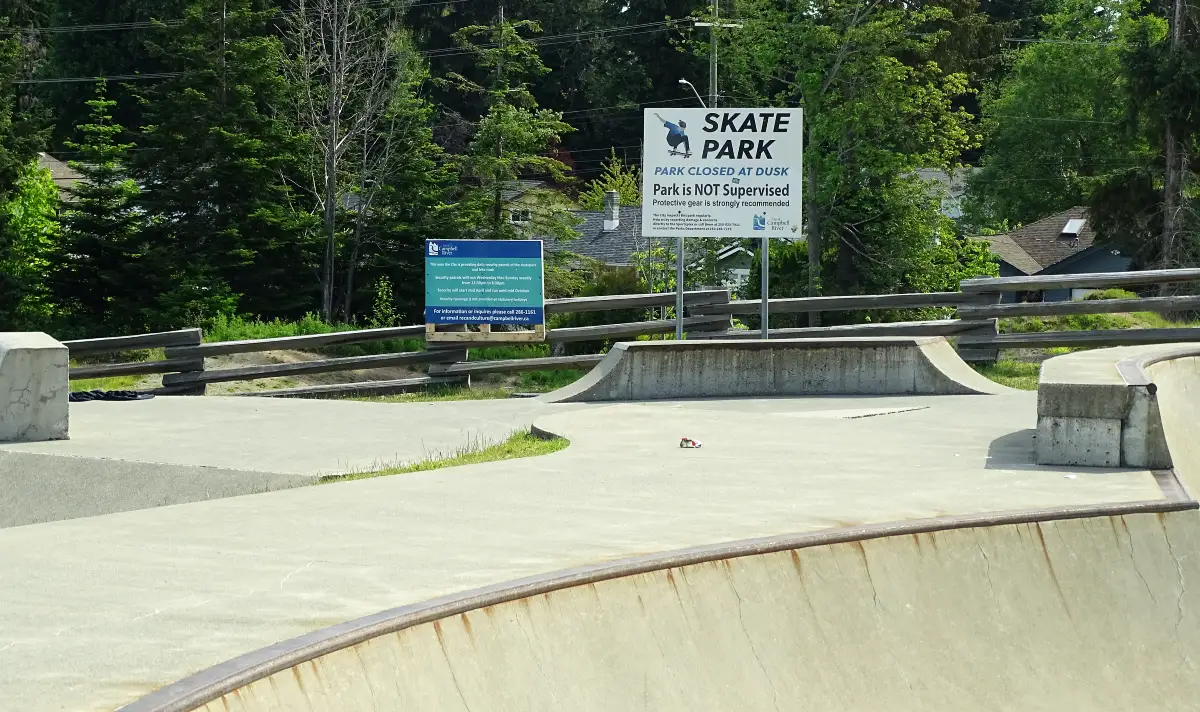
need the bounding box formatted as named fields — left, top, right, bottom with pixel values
left=715, top=0, right=978, bottom=294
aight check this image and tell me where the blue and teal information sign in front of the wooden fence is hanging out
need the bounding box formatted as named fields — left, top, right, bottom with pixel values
left=425, top=240, right=546, bottom=324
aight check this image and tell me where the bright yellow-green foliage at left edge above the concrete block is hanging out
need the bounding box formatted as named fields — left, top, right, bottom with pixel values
left=0, top=163, right=60, bottom=329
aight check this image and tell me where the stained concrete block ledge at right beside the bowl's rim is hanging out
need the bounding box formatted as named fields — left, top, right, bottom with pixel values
left=1034, top=343, right=1200, bottom=469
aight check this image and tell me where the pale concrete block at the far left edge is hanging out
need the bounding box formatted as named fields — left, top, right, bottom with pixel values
left=0, top=331, right=71, bottom=442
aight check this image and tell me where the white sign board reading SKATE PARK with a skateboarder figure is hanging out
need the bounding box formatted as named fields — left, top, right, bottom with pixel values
left=642, top=108, right=804, bottom=239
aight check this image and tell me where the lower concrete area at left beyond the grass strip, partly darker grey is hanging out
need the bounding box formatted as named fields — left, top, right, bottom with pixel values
left=0, top=396, right=552, bottom=527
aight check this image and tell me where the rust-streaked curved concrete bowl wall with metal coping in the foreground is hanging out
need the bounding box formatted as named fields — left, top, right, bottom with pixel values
left=124, top=501, right=1200, bottom=712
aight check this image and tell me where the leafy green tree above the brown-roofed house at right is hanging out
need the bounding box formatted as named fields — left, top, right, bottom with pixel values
left=965, top=0, right=1147, bottom=231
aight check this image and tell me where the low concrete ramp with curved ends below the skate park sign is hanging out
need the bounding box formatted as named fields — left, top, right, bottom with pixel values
left=542, top=336, right=1009, bottom=402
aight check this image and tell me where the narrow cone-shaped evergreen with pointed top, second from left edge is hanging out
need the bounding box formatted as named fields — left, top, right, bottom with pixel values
left=54, top=80, right=152, bottom=335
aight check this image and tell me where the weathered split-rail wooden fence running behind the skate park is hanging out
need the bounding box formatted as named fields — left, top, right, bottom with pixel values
left=58, top=269, right=1200, bottom=396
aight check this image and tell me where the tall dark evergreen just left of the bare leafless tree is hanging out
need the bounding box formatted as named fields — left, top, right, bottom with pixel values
left=133, top=0, right=317, bottom=327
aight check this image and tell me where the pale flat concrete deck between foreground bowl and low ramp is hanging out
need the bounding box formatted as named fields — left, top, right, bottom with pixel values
left=0, top=393, right=1171, bottom=712
